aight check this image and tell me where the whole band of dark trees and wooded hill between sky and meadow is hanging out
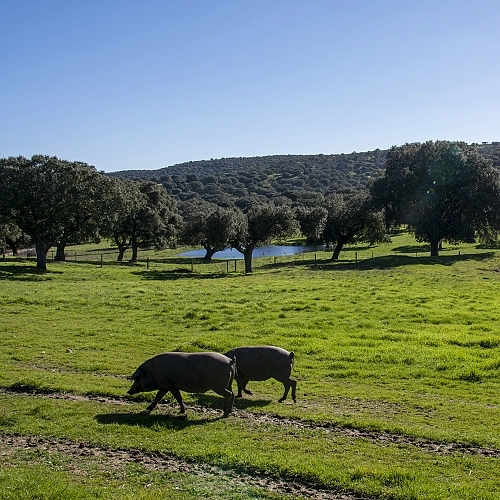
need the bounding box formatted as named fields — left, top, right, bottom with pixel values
left=0, top=141, right=500, bottom=272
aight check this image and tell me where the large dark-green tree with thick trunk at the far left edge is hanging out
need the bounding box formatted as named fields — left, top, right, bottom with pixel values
left=0, top=155, right=109, bottom=270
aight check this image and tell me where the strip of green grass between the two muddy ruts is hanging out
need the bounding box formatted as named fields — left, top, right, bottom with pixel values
left=3, top=396, right=500, bottom=499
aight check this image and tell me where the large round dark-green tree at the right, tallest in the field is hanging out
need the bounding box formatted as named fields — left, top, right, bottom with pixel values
left=371, top=141, right=500, bottom=256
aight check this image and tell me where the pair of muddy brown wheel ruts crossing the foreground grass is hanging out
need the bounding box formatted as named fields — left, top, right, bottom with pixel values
left=0, top=389, right=500, bottom=500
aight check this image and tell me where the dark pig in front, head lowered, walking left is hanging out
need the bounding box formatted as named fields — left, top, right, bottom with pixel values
left=128, top=352, right=235, bottom=417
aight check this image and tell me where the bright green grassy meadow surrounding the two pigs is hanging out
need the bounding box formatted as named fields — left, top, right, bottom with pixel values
left=0, top=233, right=500, bottom=500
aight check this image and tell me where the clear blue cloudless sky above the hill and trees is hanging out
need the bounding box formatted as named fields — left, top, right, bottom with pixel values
left=0, top=0, right=500, bottom=172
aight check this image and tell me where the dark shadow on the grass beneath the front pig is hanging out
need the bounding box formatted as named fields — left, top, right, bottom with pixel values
left=95, top=408, right=222, bottom=431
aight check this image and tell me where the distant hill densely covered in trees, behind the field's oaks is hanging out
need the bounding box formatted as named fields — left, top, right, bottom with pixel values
left=108, top=142, right=500, bottom=205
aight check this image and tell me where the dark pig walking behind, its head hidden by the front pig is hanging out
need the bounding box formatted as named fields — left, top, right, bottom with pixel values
left=226, top=345, right=297, bottom=403
